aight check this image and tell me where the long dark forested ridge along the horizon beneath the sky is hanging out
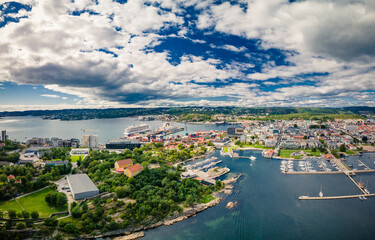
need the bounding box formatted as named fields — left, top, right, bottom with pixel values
left=0, top=106, right=375, bottom=120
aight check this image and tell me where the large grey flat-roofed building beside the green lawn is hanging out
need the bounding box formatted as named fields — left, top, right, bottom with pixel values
left=66, top=174, right=99, bottom=200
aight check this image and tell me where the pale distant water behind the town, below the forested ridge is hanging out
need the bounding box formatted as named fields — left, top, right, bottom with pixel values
left=0, top=117, right=228, bottom=144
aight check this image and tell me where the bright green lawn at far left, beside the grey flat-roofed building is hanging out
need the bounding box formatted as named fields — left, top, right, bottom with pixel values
left=0, top=188, right=68, bottom=217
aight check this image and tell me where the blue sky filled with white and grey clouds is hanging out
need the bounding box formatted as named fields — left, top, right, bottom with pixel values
left=0, top=0, right=375, bottom=111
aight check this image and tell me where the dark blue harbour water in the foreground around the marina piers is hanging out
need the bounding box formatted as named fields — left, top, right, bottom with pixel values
left=144, top=151, right=375, bottom=240
